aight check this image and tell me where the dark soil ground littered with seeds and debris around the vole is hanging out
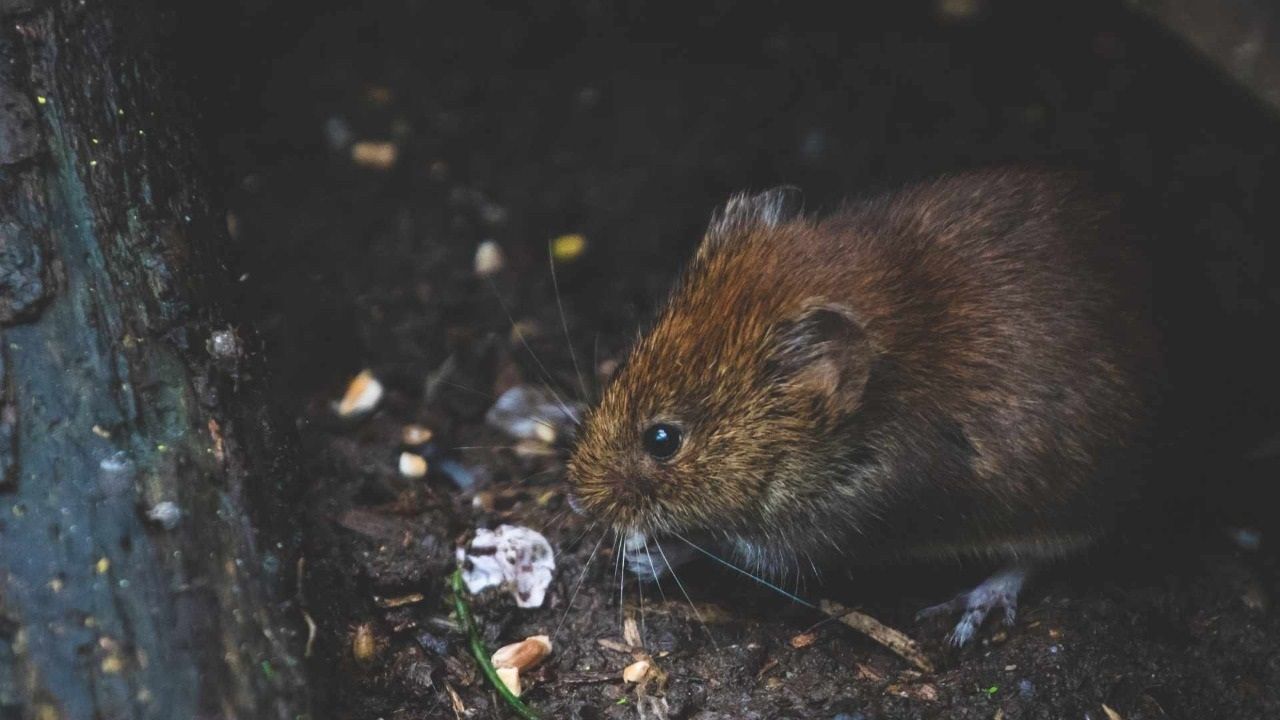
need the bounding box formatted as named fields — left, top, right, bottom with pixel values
left=211, top=0, right=1280, bottom=720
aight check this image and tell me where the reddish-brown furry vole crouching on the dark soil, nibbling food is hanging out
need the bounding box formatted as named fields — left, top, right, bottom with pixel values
left=570, top=169, right=1157, bottom=643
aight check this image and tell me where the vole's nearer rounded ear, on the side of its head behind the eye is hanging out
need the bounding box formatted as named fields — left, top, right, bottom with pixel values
left=772, top=304, right=873, bottom=413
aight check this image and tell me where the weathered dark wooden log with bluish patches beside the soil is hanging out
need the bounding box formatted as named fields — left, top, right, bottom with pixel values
left=0, top=0, right=306, bottom=720
